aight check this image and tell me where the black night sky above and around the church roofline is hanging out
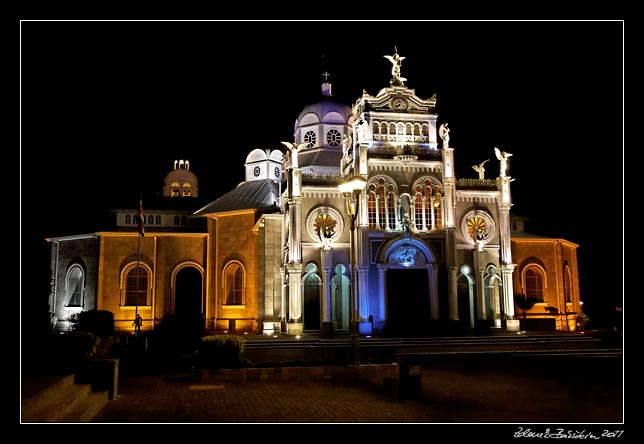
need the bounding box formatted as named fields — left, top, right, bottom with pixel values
left=20, top=21, right=624, bottom=326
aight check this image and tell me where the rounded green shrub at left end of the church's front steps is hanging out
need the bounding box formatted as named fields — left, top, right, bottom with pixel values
left=194, top=335, right=244, bottom=369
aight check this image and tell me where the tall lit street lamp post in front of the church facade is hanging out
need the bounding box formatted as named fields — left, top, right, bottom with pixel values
left=338, top=176, right=367, bottom=364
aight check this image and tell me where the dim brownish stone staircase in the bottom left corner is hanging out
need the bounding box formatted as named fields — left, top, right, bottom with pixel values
left=21, top=374, right=110, bottom=423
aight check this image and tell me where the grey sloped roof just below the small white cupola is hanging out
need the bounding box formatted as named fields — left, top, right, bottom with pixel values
left=194, top=179, right=280, bottom=215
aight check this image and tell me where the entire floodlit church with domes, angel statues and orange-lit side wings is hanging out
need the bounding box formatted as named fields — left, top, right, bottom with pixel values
left=48, top=50, right=581, bottom=336
